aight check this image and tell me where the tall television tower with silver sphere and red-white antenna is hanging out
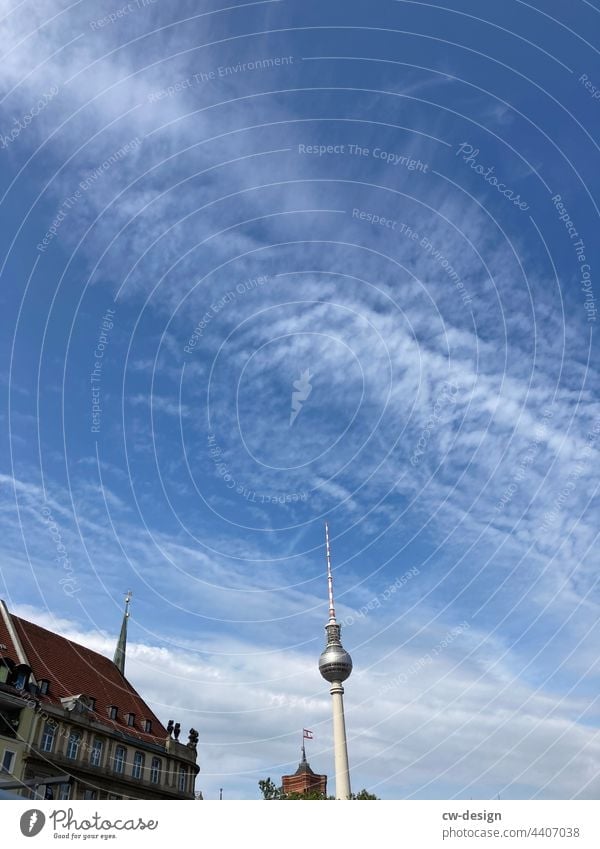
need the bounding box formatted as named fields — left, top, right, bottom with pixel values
left=319, top=522, right=352, bottom=799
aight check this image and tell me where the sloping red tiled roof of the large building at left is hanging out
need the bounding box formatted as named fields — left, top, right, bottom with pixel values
left=5, top=616, right=168, bottom=744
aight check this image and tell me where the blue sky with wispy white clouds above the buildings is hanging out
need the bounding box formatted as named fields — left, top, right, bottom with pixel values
left=0, top=0, right=600, bottom=799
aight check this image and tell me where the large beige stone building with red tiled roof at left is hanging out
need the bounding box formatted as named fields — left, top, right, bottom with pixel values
left=0, top=601, right=199, bottom=799
